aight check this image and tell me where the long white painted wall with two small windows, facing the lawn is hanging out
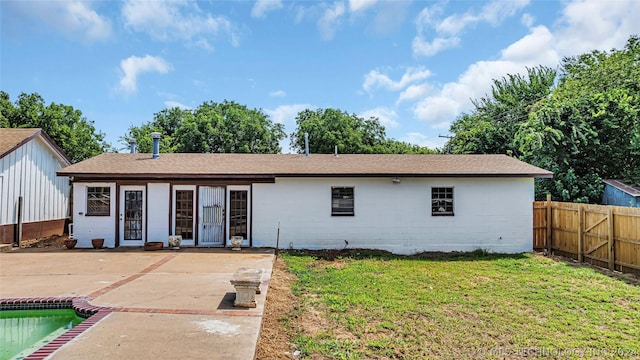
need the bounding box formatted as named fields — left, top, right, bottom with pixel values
left=252, top=178, right=534, bottom=254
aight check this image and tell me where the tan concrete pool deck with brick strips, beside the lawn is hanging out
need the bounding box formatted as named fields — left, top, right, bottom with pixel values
left=0, top=248, right=274, bottom=360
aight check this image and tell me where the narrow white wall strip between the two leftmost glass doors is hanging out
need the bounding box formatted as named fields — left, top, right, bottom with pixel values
left=147, top=183, right=171, bottom=246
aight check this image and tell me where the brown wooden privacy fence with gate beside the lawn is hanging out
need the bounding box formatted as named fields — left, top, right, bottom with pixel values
left=533, top=197, right=640, bottom=274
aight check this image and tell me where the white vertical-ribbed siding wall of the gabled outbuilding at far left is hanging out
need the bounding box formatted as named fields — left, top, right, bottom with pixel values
left=0, top=136, right=70, bottom=225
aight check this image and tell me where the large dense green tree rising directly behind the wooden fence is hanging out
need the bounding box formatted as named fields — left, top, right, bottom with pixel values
left=516, top=36, right=640, bottom=202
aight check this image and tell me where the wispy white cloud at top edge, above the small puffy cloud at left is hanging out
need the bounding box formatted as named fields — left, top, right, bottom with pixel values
left=122, top=0, right=239, bottom=50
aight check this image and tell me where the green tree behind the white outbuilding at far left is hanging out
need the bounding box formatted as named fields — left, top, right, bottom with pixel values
left=0, top=91, right=112, bottom=162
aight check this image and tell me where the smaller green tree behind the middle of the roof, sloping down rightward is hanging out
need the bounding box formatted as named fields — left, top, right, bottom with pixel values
left=291, top=109, right=433, bottom=154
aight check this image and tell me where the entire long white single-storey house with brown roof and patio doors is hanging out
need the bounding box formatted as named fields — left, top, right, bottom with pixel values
left=58, top=153, right=552, bottom=254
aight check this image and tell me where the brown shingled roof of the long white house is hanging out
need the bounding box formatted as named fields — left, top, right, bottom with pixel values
left=58, top=153, right=552, bottom=179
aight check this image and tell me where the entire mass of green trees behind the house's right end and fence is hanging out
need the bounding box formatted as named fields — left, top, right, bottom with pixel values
left=450, top=36, right=640, bottom=202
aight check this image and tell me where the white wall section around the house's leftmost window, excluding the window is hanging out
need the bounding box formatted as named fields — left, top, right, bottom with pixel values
left=73, top=182, right=118, bottom=248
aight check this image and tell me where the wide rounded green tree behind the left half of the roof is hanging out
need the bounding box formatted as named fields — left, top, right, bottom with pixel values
left=121, top=100, right=286, bottom=154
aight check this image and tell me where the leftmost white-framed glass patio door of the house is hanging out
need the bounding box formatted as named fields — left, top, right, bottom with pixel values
left=119, top=186, right=146, bottom=246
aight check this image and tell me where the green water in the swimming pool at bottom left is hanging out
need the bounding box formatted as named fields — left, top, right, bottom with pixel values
left=0, top=309, right=84, bottom=360
